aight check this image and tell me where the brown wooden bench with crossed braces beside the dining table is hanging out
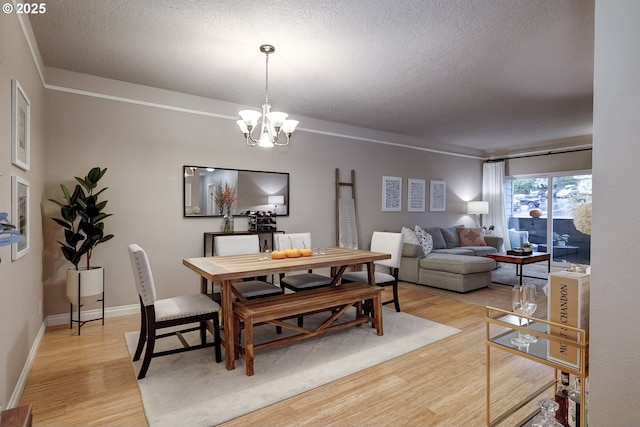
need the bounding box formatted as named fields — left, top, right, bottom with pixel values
left=233, top=282, right=383, bottom=376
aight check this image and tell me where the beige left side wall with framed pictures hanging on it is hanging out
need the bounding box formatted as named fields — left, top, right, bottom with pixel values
left=0, top=13, right=45, bottom=408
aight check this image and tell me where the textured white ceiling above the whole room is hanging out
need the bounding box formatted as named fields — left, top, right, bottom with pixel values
left=30, top=0, right=594, bottom=155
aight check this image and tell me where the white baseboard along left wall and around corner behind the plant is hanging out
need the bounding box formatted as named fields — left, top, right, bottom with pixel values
left=4, top=304, right=140, bottom=409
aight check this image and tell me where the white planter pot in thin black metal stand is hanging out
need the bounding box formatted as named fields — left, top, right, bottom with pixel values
left=67, top=267, right=104, bottom=335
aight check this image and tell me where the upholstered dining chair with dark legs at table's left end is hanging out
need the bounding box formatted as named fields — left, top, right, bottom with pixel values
left=129, top=244, right=222, bottom=380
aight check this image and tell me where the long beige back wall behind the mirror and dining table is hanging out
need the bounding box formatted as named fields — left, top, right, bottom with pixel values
left=44, top=85, right=481, bottom=315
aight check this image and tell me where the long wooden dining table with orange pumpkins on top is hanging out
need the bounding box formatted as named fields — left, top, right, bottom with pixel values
left=182, top=248, right=391, bottom=370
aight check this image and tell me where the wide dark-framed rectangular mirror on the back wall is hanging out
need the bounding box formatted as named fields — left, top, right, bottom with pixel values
left=182, top=166, right=289, bottom=217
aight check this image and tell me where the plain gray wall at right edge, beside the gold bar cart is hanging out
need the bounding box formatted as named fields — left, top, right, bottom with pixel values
left=589, top=0, right=640, bottom=426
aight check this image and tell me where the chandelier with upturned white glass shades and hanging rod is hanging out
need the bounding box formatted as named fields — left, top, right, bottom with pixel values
left=236, top=44, right=298, bottom=148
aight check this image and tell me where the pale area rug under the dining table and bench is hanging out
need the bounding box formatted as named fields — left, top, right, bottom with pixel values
left=125, top=308, right=460, bottom=427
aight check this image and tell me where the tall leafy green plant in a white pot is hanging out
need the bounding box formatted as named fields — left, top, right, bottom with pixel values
left=49, top=167, right=113, bottom=318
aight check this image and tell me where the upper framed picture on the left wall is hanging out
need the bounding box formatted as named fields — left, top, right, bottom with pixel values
left=11, top=80, right=31, bottom=171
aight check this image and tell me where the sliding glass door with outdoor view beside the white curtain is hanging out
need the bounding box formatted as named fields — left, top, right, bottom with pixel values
left=505, top=173, right=591, bottom=264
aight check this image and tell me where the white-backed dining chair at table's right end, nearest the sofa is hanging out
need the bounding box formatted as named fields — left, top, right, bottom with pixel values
left=342, top=231, right=402, bottom=312
